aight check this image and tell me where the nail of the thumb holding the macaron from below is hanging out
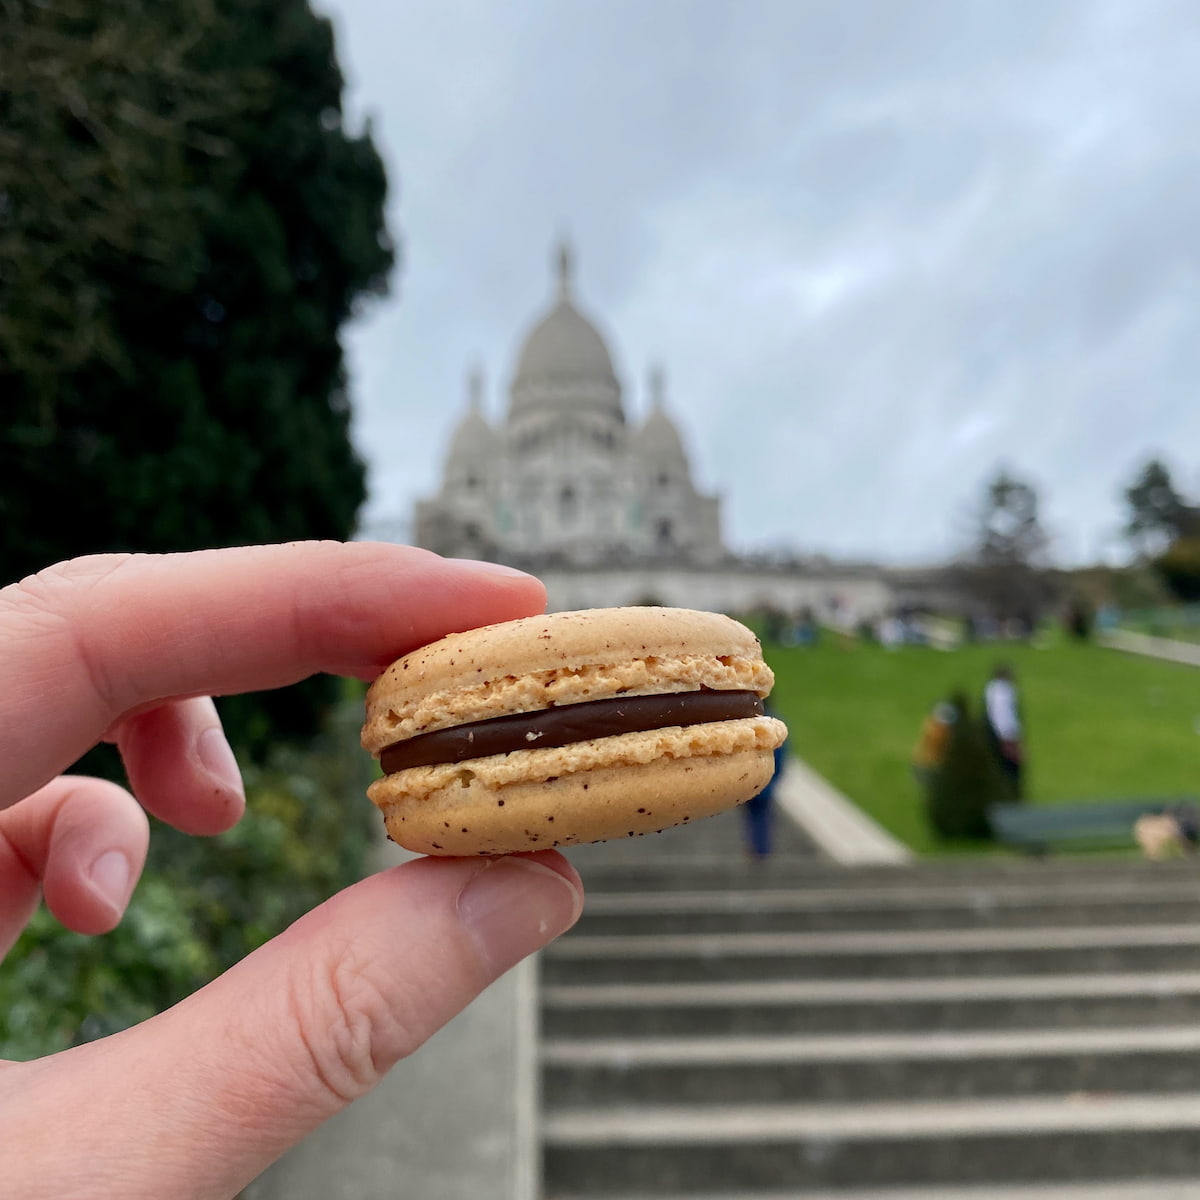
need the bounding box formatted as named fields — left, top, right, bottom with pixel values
left=458, top=858, right=583, bottom=974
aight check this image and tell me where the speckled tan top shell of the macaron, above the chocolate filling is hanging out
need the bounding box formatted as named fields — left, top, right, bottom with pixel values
left=362, top=607, right=774, bottom=755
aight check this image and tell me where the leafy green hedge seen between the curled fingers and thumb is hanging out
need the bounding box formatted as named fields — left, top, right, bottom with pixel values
left=0, top=700, right=378, bottom=1060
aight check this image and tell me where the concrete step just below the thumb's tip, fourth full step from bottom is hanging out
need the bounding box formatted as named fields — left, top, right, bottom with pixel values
left=542, top=923, right=1200, bottom=984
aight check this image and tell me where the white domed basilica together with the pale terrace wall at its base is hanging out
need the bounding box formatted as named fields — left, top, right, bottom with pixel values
left=414, top=246, right=894, bottom=620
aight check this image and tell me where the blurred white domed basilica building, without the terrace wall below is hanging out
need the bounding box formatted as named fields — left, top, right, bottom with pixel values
left=416, top=246, right=725, bottom=566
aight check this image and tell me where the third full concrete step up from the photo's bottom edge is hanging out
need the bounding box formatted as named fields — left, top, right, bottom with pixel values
left=541, top=971, right=1200, bottom=1036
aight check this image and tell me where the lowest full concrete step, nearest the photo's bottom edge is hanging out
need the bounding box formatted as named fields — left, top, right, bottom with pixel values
left=542, top=1093, right=1200, bottom=1200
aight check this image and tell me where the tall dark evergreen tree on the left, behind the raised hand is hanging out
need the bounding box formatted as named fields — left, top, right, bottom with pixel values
left=0, top=0, right=392, bottom=742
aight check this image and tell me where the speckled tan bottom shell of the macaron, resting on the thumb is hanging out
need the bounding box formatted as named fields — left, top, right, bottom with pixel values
left=368, top=746, right=774, bottom=856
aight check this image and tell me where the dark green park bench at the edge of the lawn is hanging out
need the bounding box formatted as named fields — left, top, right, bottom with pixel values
left=988, top=796, right=1196, bottom=854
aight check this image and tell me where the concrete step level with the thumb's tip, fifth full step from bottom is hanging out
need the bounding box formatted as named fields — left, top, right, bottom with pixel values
left=576, top=877, right=1200, bottom=936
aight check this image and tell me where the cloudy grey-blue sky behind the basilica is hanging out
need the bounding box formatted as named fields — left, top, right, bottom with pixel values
left=322, top=0, right=1200, bottom=562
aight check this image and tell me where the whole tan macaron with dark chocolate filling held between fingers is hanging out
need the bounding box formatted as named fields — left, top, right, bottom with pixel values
left=362, top=607, right=787, bottom=854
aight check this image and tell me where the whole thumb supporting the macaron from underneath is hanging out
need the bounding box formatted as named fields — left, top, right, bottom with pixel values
left=0, top=851, right=582, bottom=1200
